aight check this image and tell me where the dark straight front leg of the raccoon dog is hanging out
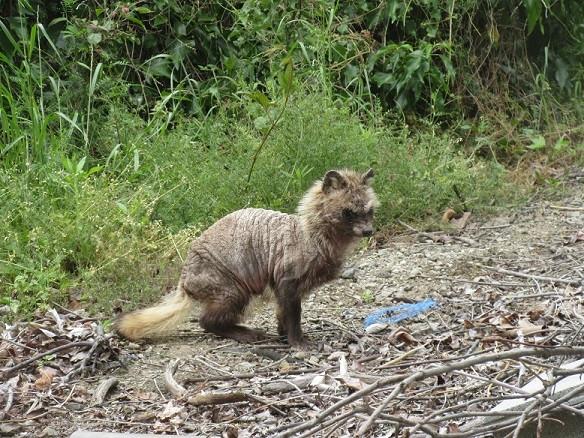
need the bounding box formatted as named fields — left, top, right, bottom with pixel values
left=277, top=281, right=306, bottom=347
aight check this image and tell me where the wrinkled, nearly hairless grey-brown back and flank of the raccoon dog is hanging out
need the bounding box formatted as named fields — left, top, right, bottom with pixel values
left=182, top=208, right=304, bottom=299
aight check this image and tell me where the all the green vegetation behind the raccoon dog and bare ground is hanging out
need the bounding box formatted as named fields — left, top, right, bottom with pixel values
left=0, top=0, right=584, bottom=315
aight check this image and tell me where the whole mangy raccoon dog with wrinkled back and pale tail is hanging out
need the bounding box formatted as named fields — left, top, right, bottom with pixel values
left=115, top=169, right=379, bottom=346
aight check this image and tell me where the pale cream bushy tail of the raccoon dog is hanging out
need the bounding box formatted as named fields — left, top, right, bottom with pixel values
left=114, top=286, right=193, bottom=341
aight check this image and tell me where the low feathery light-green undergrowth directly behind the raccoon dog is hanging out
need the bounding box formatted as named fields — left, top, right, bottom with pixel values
left=0, top=92, right=506, bottom=314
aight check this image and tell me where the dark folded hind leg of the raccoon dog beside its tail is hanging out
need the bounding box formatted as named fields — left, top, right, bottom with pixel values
left=199, top=296, right=266, bottom=343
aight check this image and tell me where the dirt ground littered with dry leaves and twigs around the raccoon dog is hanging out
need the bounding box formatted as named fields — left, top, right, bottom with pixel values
left=0, top=174, right=584, bottom=437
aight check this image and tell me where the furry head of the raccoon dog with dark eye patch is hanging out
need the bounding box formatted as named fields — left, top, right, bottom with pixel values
left=298, top=169, right=379, bottom=237
